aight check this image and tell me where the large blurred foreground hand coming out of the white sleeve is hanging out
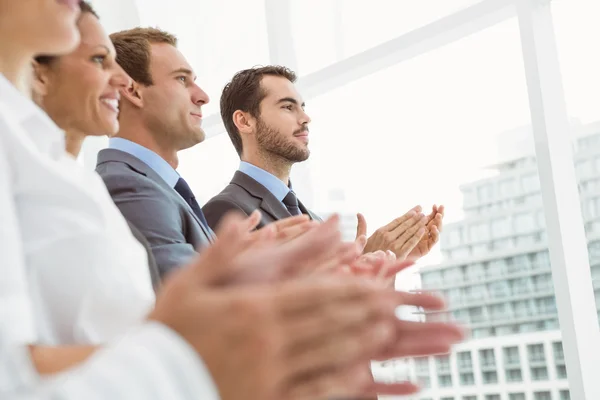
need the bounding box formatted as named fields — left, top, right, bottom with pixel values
left=149, top=216, right=438, bottom=400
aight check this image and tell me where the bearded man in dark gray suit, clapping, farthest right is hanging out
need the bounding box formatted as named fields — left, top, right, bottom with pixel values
left=203, top=65, right=444, bottom=259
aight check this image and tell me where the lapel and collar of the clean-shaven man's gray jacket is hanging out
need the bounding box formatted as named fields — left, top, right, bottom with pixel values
left=98, top=149, right=214, bottom=243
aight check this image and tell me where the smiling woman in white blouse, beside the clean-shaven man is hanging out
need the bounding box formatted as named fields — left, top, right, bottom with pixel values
left=0, top=0, right=154, bottom=346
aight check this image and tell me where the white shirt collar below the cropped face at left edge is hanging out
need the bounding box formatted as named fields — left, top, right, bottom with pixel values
left=0, top=74, right=65, bottom=157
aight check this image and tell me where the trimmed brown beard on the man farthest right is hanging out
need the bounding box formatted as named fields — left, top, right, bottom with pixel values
left=256, top=119, right=310, bottom=163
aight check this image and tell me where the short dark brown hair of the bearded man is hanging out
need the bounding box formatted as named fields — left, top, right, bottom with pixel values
left=221, top=65, right=297, bottom=156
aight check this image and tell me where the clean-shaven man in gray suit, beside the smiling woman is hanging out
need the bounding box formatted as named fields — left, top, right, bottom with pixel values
left=96, top=28, right=214, bottom=277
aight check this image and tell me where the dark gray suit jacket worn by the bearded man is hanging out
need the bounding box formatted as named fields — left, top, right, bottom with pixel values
left=202, top=171, right=321, bottom=229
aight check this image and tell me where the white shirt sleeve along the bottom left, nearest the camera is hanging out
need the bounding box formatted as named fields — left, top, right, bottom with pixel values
left=0, top=323, right=219, bottom=400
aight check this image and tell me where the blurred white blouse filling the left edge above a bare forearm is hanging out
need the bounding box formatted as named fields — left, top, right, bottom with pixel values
left=0, top=75, right=154, bottom=345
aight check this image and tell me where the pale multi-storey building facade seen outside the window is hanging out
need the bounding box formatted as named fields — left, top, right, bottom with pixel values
left=392, top=125, right=600, bottom=400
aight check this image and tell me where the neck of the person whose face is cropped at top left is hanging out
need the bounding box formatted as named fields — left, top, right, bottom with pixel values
left=0, top=44, right=33, bottom=98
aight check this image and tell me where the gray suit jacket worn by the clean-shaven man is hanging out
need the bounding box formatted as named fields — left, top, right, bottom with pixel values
left=96, top=149, right=212, bottom=278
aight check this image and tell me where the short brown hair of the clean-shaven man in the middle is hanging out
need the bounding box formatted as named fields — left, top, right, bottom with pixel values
left=110, top=28, right=177, bottom=86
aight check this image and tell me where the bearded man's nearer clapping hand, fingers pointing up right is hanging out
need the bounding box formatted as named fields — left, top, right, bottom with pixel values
left=356, top=206, right=428, bottom=260
